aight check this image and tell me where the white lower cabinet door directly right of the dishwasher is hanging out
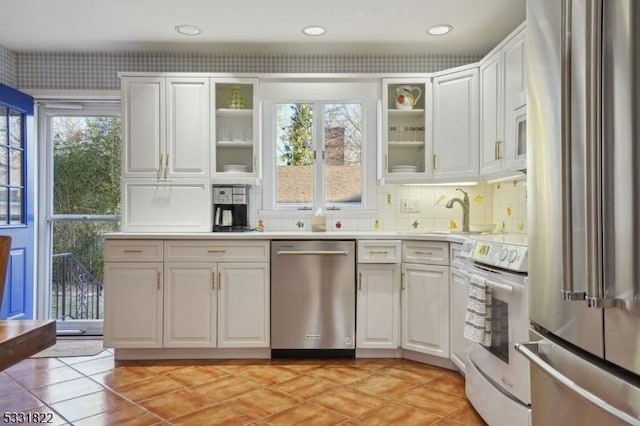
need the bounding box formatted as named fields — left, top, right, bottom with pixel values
left=356, top=264, right=400, bottom=349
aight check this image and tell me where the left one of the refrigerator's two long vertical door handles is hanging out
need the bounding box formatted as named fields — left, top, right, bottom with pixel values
left=560, top=0, right=586, bottom=301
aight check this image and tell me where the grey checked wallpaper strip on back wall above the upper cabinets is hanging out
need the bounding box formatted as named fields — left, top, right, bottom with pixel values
left=11, top=49, right=481, bottom=90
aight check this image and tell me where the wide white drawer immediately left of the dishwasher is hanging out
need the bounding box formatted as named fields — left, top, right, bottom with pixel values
left=164, top=240, right=269, bottom=262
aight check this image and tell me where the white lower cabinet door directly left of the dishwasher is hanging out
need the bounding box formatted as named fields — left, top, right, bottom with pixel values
left=218, top=263, right=270, bottom=348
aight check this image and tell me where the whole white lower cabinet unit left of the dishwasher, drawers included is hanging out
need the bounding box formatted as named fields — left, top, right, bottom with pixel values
left=104, top=240, right=270, bottom=349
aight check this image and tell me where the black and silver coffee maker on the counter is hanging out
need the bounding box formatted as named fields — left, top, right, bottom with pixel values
left=212, top=185, right=250, bottom=232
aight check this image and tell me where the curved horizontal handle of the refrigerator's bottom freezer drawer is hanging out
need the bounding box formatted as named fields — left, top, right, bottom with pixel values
left=515, top=342, right=640, bottom=426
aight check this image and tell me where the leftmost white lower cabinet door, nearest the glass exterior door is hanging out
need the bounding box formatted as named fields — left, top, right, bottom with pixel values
left=104, top=262, right=163, bottom=348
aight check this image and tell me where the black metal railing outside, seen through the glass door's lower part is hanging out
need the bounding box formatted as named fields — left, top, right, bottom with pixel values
left=51, top=253, right=103, bottom=320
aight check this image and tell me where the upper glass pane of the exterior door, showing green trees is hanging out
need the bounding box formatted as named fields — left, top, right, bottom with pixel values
left=52, top=117, right=120, bottom=214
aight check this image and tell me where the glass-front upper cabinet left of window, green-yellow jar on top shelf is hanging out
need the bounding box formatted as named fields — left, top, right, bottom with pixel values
left=211, top=78, right=260, bottom=183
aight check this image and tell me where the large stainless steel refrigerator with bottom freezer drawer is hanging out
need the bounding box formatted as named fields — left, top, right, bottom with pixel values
left=518, top=0, right=640, bottom=426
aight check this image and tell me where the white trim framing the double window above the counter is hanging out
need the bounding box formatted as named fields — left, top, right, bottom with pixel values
left=259, top=78, right=381, bottom=217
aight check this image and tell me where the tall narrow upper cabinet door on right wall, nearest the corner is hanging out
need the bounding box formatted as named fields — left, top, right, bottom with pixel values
left=480, top=51, right=504, bottom=174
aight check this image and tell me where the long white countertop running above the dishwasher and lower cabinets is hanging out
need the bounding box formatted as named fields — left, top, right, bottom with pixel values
left=104, top=231, right=480, bottom=243
